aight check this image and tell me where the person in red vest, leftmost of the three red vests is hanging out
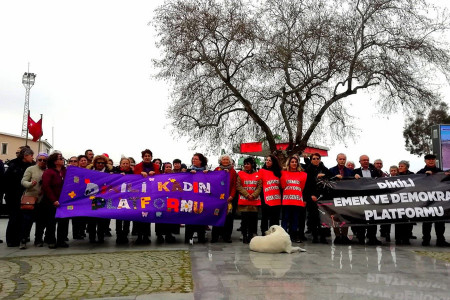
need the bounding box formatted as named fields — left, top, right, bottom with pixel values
left=236, top=157, right=262, bottom=244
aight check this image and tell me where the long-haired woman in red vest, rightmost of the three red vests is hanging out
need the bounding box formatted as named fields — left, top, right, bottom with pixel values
left=280, top=156, right=307, bottom=243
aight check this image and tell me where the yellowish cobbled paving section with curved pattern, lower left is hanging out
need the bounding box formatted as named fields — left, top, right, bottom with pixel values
left=0, top=250, right=193, bottom=299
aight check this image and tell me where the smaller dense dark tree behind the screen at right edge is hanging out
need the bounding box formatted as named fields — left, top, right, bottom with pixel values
left=403, top=102, right=450, bottom=156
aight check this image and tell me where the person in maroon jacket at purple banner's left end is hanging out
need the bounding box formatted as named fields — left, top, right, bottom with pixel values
left=40, top=152, right=69, bottom=249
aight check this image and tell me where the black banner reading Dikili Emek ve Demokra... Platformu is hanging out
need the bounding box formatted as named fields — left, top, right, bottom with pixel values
left=318, top=173, right=450, bottom=227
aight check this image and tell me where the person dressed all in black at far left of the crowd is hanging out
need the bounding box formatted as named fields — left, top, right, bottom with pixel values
left=4, top=146, right=34, bottom=247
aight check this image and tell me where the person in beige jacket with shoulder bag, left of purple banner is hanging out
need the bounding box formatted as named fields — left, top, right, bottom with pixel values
left=19, top=152, right=48, bottom=249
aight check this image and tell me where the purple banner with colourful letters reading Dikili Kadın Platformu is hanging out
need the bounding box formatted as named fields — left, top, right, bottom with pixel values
left=56, top=166, right=230, bottom=226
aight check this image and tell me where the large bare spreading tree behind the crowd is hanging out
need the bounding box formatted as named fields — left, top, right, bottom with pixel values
left=153, top=0, right=450, bottom=163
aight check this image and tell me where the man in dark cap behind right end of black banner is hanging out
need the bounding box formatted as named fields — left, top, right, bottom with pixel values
left=417, top=154, right=450, bottom=247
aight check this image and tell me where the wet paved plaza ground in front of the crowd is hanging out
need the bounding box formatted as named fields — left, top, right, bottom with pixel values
left=0, top=219, right=450, bottom=300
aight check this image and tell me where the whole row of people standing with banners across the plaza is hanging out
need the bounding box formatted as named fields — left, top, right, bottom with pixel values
left=1, top=146, right=450, bottom=249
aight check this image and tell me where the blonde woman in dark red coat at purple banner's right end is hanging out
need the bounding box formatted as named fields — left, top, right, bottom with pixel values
left=211, top=154, right=237, bottom=243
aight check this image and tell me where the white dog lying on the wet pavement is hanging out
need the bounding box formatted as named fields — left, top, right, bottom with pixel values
left=250, top=225, right=306, bottom=253
